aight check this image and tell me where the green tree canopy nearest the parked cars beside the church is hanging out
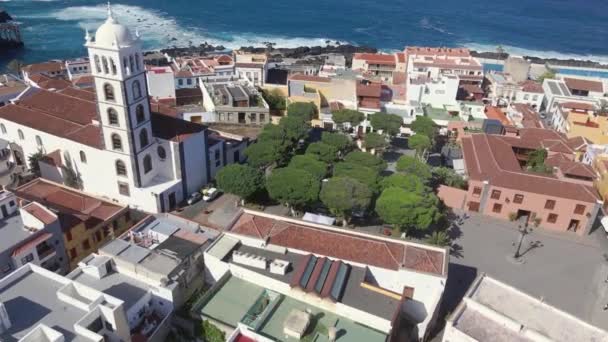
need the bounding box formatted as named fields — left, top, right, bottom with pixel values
left=215, top=164, right=264, bottom=199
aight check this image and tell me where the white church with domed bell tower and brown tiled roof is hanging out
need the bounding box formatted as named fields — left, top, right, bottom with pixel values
left=0, top=8, right=210, bottom=213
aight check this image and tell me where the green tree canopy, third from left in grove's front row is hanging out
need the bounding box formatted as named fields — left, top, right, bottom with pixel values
left=319, top=177, right=373, bottom=220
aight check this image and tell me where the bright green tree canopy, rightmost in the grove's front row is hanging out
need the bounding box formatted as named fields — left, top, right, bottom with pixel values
left=376, top=188, right=441, bottom=231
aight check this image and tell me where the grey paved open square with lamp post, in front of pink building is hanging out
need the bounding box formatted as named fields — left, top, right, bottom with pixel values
left=443, top=215, right=608, bottom=330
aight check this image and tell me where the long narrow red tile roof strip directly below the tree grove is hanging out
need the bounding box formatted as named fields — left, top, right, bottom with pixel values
left=230, top=212, right=446, bottom=275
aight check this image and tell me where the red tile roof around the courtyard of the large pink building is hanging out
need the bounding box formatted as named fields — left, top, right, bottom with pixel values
left=462, top=132, right=599, bottom=203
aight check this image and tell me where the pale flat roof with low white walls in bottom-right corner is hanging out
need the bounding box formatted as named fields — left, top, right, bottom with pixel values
left=448, top=274, right=608, bottom=342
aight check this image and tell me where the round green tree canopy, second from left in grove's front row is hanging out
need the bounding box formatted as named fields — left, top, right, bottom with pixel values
left=266, top=167, right=320, bottom=208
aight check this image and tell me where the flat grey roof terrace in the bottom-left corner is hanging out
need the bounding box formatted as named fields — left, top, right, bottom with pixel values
left=0, top=269, right=88, bottom=342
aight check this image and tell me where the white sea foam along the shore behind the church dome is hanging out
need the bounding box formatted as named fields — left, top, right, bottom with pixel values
left=35, top=5, right=344, bottom=48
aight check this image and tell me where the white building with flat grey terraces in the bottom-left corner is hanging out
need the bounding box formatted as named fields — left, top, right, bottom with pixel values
left=0, top=254, right=173, bottom=342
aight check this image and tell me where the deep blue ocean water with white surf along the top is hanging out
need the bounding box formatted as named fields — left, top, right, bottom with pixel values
left=0, top=0, right=608, bottom=67
